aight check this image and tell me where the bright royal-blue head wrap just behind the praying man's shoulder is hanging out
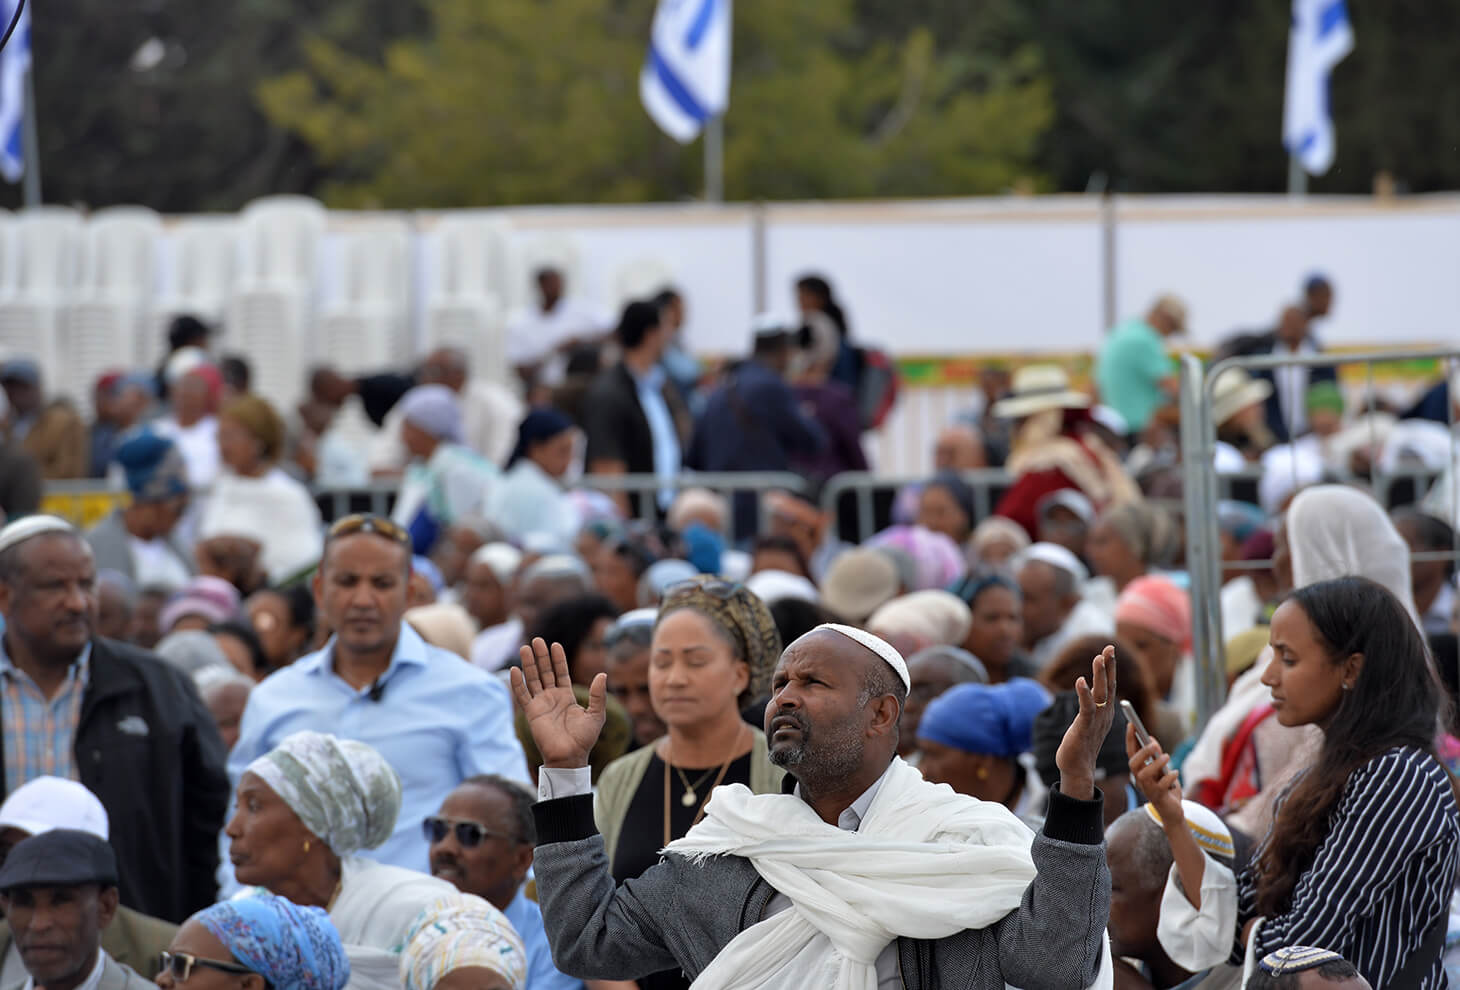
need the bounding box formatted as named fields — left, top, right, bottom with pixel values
left=917, top=678, right=1050, bottom=759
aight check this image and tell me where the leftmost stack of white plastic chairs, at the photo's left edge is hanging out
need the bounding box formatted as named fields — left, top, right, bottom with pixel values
left=0, top=206, right=82, bottom=388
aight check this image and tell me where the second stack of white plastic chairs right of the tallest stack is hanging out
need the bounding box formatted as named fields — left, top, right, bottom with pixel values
left=422, top=215, right=511, bottom=384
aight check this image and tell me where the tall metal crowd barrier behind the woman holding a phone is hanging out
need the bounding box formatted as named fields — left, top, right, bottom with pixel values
left=1180, top=349, right=1460, bottom=730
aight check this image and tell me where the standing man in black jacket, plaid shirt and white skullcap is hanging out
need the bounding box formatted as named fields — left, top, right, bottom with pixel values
left=0, top=515, right=229, bottom=921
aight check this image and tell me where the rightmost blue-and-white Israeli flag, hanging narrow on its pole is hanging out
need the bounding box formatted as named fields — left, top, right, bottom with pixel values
left=1282, top=0, right=1353, bottom=175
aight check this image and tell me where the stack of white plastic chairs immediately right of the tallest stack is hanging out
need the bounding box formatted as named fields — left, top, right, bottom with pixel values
left=320, top=219, right=415, bottom=372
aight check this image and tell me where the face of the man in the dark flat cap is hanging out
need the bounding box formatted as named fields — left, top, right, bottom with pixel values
left=0, top=883, right=117, bottom=989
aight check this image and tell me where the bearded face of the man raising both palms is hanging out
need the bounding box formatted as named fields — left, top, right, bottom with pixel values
left=765, top=629, right=904, bottom=794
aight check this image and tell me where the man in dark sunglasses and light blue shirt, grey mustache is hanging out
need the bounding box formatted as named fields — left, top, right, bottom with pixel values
left=420, top=777, right=583, bottom=990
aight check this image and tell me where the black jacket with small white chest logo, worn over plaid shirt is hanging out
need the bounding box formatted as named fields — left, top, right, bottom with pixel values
left=0, top=638, right=229, bottom=923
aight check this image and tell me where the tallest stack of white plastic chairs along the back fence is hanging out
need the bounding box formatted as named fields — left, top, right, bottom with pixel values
left=226, top=196, right=326, bottom=412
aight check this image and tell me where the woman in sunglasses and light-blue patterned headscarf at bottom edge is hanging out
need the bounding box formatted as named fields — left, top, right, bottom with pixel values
left=158, top=894, right=350, bottom=990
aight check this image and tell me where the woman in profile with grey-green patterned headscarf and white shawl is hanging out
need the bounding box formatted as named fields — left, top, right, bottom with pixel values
left=225, top=732, right=454, bottom=990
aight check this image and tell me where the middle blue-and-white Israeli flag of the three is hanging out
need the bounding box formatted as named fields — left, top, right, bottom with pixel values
left=639, top=0, right=731, bottom=145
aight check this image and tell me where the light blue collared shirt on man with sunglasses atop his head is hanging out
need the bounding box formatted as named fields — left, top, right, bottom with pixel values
left=228, top=622, right=529, bottom=870
